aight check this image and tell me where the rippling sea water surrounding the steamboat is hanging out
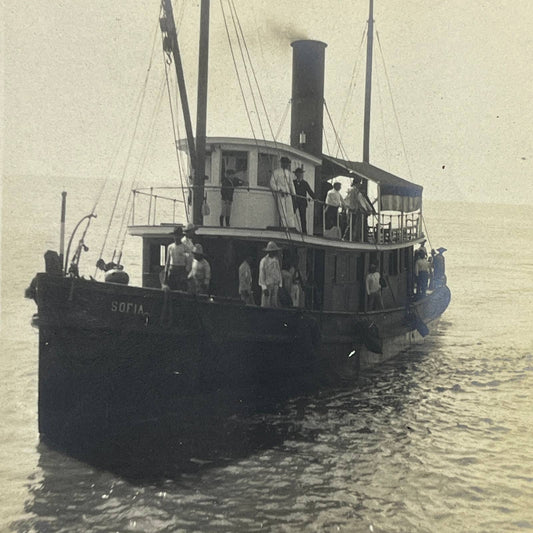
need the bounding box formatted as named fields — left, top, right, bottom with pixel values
left=0, top=178, right=533, bottom=533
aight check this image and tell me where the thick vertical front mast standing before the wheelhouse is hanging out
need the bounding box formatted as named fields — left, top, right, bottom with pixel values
left=192, top=0, right=210, bottom=225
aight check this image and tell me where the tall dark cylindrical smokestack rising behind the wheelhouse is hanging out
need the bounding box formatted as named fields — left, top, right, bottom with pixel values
left=291, top=40, right=327, bottom=158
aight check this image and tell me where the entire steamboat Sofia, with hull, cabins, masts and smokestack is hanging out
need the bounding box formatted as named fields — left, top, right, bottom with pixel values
left=26, top=0, right=450, bottom=443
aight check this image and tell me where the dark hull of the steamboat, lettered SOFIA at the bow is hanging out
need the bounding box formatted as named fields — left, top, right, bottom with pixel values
left=36, top=274, right=450, bottom=444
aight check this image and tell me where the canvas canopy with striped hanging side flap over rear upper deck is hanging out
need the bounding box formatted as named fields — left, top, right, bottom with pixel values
left=322, top=155, right=422, bottom=213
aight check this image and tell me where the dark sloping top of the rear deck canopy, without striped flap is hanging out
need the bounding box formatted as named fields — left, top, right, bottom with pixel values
left=322, top=155, right=423, bottom=196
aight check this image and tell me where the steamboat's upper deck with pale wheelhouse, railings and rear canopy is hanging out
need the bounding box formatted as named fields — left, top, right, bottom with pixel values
left=129, top=137, right=422, bottom=249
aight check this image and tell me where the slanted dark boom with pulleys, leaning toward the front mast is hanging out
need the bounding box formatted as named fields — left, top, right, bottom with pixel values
left=159, top=0, right=196, bottom=167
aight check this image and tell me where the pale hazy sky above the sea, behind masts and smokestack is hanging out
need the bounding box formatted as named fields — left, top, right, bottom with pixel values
left=2, top=0, right=533, bottom=204
